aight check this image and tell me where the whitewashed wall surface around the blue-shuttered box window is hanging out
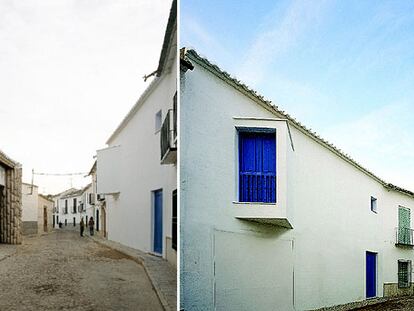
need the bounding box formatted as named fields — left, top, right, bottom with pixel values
left=180, top=59, right=414, bottom=310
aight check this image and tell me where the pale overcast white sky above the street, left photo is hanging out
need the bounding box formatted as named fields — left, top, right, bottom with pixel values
left=0, top=0, right=171, bottom=193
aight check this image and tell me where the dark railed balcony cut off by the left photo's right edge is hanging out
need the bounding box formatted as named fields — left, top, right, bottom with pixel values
left=160, top=108, right=177, bottom=164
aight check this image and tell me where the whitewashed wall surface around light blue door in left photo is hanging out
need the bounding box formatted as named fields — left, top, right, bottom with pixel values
left=97, top=47, right=177, bottom=264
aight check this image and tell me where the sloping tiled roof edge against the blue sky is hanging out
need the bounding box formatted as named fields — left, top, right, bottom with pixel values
left=184, top=48, right=414, bottom=197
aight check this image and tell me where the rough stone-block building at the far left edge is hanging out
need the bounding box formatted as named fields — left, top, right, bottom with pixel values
left=0, top=151, right=22, bottom=244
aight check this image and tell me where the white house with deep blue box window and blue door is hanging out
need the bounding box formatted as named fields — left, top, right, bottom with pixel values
left=180, top=50, right=414, bottom=310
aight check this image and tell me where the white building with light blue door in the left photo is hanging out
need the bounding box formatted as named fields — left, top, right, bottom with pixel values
left=97, top=1, right=177, bottom=265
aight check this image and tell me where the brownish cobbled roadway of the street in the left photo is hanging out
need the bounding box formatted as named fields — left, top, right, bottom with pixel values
left=0, top=230, right=163, bottom=311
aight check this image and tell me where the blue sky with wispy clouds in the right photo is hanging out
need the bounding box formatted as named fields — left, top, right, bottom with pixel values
left=180, top=0, right=414, bottom=191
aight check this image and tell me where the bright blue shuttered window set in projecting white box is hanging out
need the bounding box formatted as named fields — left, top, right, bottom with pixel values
left=239, top=131, right=276, bottom=203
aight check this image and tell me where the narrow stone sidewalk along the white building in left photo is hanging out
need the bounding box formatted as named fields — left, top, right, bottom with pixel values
left=85, top=232, right=177, bottom=311
